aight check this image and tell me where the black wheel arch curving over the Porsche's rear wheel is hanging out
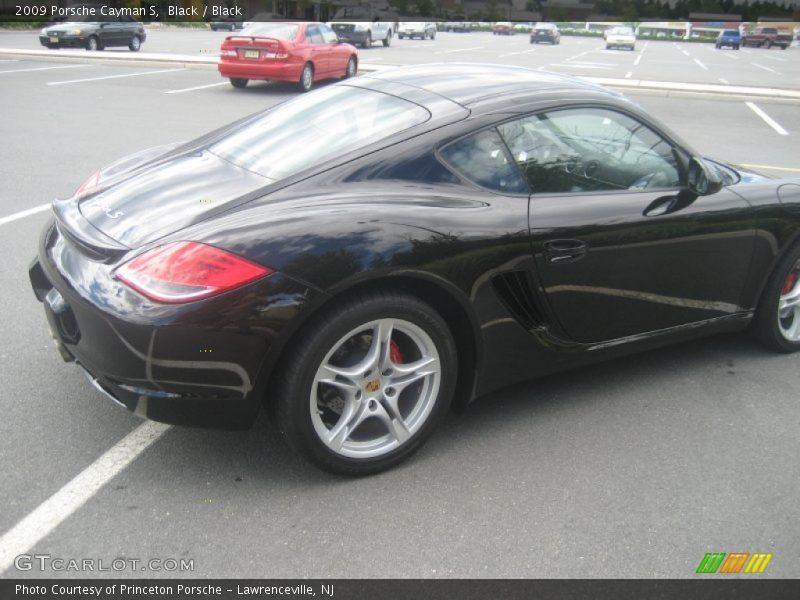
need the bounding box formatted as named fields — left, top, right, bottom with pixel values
left=259, top=271, right=483, bottom=412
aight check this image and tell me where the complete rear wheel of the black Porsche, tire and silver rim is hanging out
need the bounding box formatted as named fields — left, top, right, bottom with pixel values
left=274, top=292, right=458, bottom=475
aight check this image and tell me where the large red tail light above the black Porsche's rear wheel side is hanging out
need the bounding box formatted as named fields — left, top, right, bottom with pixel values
left=115, top=242, right=273, bottom=304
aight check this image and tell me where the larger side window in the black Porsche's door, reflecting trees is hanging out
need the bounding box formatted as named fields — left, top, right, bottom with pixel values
left=498, top=108, right=681, bottom=194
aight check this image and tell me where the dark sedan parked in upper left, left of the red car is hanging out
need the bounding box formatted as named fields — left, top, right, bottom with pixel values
left=39, top=16, right=147, bottom=52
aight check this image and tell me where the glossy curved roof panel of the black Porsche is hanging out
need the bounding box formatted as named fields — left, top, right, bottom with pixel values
left=359, top=63, right=618, bottom=106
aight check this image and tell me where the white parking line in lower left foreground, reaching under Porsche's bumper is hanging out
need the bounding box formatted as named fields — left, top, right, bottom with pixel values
left=0, top=421, right=170, bottom=574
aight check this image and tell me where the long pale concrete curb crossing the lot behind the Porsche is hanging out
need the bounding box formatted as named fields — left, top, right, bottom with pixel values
left=0, top=48, right=800, bottom=100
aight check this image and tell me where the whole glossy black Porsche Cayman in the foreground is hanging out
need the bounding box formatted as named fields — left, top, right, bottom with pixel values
left=30, top=64, right=800, bottom=474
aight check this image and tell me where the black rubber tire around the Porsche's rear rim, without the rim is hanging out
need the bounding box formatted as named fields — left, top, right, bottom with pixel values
left=273, top=292, right=458, bottom=476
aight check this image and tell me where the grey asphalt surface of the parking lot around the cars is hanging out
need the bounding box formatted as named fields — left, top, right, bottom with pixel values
left=0, top=32, right=800, bottom=578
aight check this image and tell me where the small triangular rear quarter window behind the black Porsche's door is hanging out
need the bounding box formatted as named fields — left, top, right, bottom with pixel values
left=441, top=129, right=528, bottom=194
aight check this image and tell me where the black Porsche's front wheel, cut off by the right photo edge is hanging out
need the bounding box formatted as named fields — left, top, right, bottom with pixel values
left=753, top=243, right=800, bottom=352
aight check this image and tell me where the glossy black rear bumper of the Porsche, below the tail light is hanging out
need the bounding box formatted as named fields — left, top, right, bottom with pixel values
left=29, top=223, right=316, bottom=429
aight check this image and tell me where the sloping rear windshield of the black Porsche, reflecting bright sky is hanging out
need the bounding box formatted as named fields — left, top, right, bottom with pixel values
left=209, top=85, right=430, bottom=180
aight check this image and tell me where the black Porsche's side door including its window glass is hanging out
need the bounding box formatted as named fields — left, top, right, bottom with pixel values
left=498, top=107, right=754, bottom=343
